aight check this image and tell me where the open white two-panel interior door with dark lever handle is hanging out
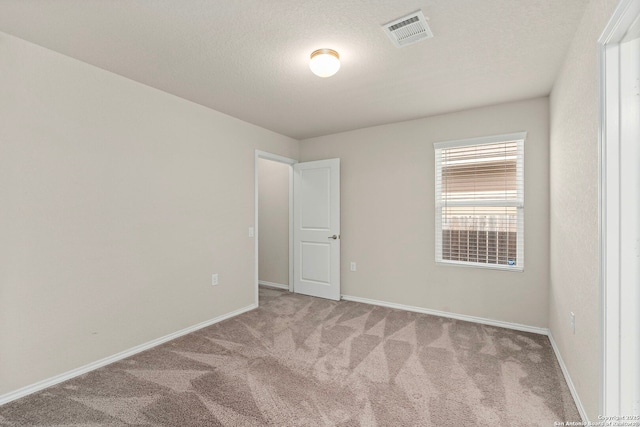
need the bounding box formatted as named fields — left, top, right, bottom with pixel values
left=293, top=159, right=340, bottom=301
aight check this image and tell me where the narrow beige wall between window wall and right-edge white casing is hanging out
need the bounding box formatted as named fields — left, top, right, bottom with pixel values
left=549, top=0, right=617, bottom=421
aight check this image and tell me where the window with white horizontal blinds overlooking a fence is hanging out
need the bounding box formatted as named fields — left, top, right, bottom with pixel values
left=434, top=132, right=526, bottom=271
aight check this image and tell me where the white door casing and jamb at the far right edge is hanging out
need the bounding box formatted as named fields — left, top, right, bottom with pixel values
left=598, top=0, right=640, bottom=416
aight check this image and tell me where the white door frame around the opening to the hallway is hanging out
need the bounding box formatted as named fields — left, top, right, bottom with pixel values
left=253, top=150, right=298, bottom=306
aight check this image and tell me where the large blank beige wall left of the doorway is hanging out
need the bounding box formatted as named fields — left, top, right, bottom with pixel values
left=0, top=33, right=298, bottom=395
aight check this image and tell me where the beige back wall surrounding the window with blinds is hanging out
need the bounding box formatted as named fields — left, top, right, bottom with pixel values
left=300, top=98, right=549, bottom=327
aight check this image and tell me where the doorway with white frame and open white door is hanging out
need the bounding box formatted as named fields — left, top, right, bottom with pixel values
left=253, top=150, right=341, bottom=306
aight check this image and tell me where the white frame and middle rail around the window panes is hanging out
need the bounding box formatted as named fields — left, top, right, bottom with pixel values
left=433, top=132, right=527, bottom=272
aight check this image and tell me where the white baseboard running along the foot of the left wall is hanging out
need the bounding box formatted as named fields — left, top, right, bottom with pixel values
left=0, top=304, right=257, bottom=405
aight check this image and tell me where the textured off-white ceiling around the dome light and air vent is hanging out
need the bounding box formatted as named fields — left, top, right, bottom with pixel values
left=0, top=0, right=587, bottom=139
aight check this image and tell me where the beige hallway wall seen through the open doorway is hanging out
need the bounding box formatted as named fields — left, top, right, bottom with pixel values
left=258, top=159, right=290, bottom=286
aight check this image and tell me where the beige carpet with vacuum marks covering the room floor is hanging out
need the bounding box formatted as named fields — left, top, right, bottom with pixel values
left=0, top=288, right=580, bottom=427
